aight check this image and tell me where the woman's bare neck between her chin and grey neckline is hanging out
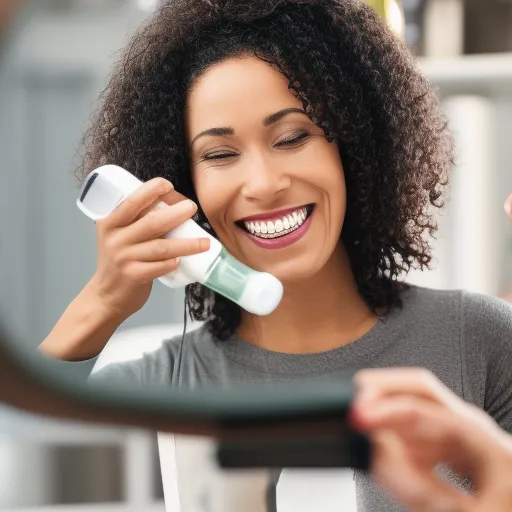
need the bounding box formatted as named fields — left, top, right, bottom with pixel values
left=237, top=243, right=377, bottom=353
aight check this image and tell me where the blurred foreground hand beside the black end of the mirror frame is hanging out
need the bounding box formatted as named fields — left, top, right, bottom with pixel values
left=353, top=368, right=512, bottom=512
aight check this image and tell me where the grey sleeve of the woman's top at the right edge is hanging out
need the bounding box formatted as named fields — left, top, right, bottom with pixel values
left=460, top=293, right=512, bottom=433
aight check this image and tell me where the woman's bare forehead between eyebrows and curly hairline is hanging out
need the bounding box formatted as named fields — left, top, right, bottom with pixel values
left=187, top=56, right=302, bottom=136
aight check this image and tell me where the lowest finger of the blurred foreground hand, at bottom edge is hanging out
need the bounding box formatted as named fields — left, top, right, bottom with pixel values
left=372, top=431, right=472, bottom=512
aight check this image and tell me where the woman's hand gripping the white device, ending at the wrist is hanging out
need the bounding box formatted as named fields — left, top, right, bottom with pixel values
left=90, top=178, right=210, bottom=320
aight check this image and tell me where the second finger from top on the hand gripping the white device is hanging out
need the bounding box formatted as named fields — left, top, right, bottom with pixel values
left=123, top=199, right=197, bottom=245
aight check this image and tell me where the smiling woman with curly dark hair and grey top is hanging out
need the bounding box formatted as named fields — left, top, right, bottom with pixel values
left=41, top=0, right=512, bottom=511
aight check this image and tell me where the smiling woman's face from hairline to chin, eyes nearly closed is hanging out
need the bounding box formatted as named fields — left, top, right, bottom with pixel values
left=187, top=57, right=346, bottom=282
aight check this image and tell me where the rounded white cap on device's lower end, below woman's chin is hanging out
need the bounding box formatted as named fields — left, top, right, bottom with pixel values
left=237, top=272, right=283, bottom=316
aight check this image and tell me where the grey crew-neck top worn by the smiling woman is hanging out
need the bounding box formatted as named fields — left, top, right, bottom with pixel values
left=94, top=286, right=512, bottom=512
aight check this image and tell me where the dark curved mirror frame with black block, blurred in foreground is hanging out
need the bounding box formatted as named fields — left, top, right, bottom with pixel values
left=0, top=322, right=371, bottom=469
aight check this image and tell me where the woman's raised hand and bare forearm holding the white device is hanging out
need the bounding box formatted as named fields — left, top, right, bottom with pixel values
left=39, top=178, right=210, bottom=361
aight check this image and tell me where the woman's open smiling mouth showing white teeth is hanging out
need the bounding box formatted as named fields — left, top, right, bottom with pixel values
left=236, top=204, right=315, bottom=240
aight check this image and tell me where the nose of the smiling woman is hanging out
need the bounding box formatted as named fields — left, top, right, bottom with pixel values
left=242, top=153, right=291, bottom=202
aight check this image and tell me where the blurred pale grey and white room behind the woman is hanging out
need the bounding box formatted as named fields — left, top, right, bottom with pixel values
left=0, top=0, right=512, bottom=512
